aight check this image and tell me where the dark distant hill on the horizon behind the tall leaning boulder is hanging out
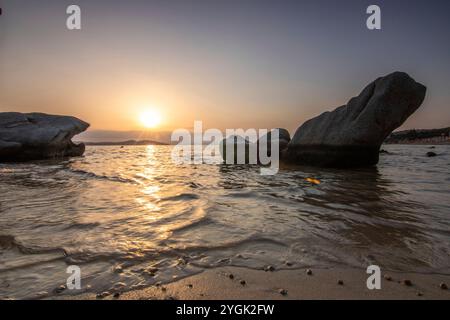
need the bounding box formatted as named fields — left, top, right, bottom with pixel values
left=384, top=127, right=450, bottom=144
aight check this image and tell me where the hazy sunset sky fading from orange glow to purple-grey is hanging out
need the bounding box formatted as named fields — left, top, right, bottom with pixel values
left=0, top=0, right=450, bottom=138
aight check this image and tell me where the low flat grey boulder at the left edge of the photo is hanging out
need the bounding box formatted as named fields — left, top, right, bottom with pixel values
left=0, top=112, right=89, bottom=161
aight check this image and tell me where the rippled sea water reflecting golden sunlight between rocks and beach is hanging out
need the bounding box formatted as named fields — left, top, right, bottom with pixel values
left=0, top=146, right=450, bottom=298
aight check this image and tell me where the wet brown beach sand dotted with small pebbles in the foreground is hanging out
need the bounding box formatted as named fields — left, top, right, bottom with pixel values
left=64, top=267, right=450, bottom=300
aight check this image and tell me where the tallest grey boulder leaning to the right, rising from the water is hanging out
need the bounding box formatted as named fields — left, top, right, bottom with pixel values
left=286, top=72, right=426, bottom=167
